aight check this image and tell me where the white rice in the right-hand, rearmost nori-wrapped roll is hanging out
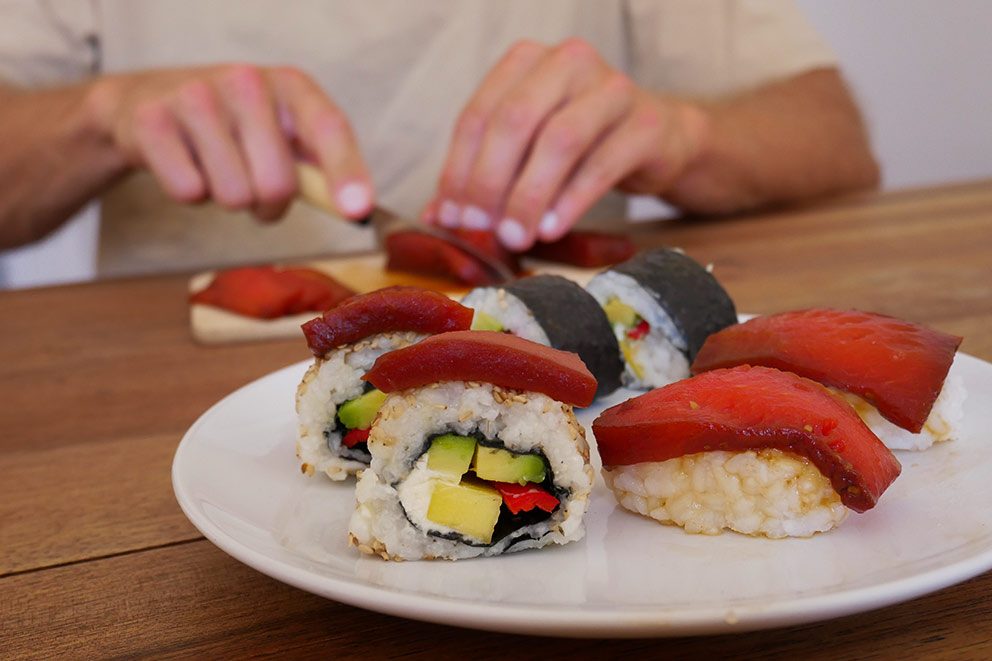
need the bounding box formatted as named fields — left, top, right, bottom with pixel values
left=586, top=271, right=689, bottom=390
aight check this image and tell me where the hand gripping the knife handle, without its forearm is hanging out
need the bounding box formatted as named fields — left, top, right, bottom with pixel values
left=91, top=64, right=374, bottom=220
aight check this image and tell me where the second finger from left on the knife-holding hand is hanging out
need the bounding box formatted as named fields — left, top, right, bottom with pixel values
left=176, top=80, right=253, bottom=209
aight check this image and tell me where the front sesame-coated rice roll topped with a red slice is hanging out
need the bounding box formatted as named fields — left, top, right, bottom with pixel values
left=349, top=331, right=596, bottom=560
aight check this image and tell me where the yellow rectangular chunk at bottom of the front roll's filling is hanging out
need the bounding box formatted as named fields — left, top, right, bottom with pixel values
left=427, top=480, right=503, bottom=544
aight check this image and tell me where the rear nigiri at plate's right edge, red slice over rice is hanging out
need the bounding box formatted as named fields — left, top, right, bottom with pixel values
left=692, top=308, right=967, bottom=450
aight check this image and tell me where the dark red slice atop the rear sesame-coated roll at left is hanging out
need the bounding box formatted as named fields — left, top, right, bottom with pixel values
left=303, top=287, right=473, bottom=357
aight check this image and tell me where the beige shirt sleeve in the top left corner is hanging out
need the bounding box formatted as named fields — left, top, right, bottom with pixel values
left=0, top=0, right=99, bottom=87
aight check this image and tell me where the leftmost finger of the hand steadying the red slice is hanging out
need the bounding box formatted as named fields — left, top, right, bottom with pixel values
left=437, top=41, right=548, bottom=227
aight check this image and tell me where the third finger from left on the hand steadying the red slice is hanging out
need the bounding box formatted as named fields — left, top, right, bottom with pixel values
left=496, top=73, right=635, bottom=250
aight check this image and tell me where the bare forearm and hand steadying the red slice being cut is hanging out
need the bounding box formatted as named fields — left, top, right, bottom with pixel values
left=428, top=39, right=878, bottom=250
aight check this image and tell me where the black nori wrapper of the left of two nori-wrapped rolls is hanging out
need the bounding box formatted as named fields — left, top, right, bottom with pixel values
left=505, top=275, right=623, bottom=397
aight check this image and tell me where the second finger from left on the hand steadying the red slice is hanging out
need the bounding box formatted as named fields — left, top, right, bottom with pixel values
left=462, top=39, right=607, bottom=232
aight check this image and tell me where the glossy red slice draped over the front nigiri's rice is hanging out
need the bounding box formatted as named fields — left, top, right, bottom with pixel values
left=592, top=365, right=901, bottom=512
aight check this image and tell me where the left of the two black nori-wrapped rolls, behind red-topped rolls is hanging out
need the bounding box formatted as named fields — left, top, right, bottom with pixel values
left=462, top=275, right=623, bottom=396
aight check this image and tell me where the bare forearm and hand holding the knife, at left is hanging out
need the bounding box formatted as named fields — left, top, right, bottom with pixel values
left=0, top=64, right=373, bottom=249
